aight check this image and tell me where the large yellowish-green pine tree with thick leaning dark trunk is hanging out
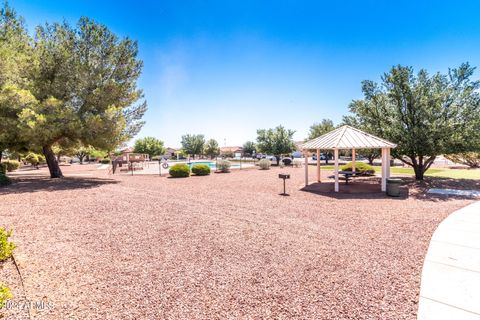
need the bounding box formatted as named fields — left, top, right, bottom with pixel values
left=0, top=9, right=146, bottom=178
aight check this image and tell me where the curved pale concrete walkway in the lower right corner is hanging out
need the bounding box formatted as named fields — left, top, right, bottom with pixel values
left=418, top=201, right=480, bottom=320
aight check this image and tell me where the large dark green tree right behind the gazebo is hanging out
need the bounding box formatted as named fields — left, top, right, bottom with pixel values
left=349, top=64, right=480, bottom=180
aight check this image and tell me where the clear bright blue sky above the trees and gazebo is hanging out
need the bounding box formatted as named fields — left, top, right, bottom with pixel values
left=9, top=0, right=480, bottom=147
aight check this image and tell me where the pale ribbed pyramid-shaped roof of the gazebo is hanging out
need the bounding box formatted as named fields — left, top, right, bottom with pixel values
left=302, top=125, right=397, bottom=149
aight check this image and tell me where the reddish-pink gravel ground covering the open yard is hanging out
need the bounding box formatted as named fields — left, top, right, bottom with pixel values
left=0, top=166, right=472, bottom=319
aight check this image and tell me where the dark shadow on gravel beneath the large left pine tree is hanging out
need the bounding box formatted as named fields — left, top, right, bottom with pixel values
left=0, top=177, right=119, bottom=195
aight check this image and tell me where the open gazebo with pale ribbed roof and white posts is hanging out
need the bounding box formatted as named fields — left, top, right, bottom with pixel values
left=301, top=125, right=397, bottom=192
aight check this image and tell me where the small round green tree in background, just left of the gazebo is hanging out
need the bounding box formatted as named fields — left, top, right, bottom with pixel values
left=257, top=126, right=295, bottom=165
